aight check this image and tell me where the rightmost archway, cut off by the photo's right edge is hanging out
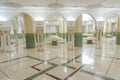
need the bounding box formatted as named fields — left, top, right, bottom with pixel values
left=103, top=14, right=119, bottom=44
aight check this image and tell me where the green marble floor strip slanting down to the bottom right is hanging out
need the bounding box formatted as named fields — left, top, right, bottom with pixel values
left=80, top=70, right=115, bottom=80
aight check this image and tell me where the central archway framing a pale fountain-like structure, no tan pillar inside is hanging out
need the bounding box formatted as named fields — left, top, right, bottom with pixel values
left=44, top=13, right=67, bottom=44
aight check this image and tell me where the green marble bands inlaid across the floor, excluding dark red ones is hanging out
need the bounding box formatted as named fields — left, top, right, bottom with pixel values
left=0, top=50, right=115, bottom=80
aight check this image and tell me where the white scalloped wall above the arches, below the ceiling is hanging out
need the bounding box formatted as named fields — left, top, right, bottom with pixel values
left=0, top=7, right=120, bottom=31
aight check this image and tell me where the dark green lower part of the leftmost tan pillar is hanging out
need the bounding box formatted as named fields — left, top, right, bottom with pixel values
left=25, top=33, right=35, bottom=48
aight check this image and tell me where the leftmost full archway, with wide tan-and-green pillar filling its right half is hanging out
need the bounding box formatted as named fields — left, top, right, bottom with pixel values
left=11, top=13, right=35, bottom=48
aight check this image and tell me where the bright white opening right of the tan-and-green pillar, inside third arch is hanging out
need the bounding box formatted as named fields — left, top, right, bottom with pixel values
left=82, top=13, right=96, bottom=44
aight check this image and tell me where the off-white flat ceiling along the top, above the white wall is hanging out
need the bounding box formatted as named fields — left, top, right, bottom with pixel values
left=0, top=0, right=120, bottom=8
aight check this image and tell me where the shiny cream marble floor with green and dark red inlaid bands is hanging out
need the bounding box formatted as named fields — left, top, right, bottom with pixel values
left=0, top=38, right=120, bottom=80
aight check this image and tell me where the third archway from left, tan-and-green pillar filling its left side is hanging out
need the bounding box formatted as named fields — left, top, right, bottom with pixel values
left=74, top=14, right=96, bottom=47
